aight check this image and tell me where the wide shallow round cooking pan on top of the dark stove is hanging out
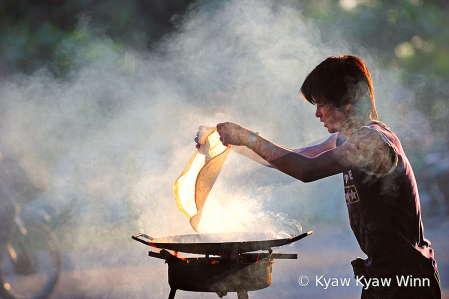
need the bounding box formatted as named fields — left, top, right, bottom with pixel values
left=132, top=231, right=312, bottom=255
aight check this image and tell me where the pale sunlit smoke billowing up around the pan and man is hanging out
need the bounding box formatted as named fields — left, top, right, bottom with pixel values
left=0, top=0, right=426, bottom=298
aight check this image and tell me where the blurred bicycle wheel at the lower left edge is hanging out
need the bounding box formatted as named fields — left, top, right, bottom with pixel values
left=0, top=223, right=61, bottom=299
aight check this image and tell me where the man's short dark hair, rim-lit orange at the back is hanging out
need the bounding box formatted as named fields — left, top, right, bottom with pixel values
left=300, top=55, right=377, bottom=120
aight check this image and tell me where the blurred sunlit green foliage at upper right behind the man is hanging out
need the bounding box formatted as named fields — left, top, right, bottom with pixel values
left=298, top=0, right=449, bottom=150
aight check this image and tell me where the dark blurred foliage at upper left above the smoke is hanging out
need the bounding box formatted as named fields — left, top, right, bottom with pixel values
left=0, top=0, right=191, bottom=75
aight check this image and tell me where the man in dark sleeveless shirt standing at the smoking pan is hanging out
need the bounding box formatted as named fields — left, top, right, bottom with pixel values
left=217, top=55, right=441, bottom=298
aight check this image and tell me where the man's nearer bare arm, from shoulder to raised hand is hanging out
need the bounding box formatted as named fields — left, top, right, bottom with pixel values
left=217, top=123, right=392, bottom=182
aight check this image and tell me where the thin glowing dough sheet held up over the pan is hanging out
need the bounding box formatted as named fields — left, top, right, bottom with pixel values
left=173, top=126, right=231, bottom=231
